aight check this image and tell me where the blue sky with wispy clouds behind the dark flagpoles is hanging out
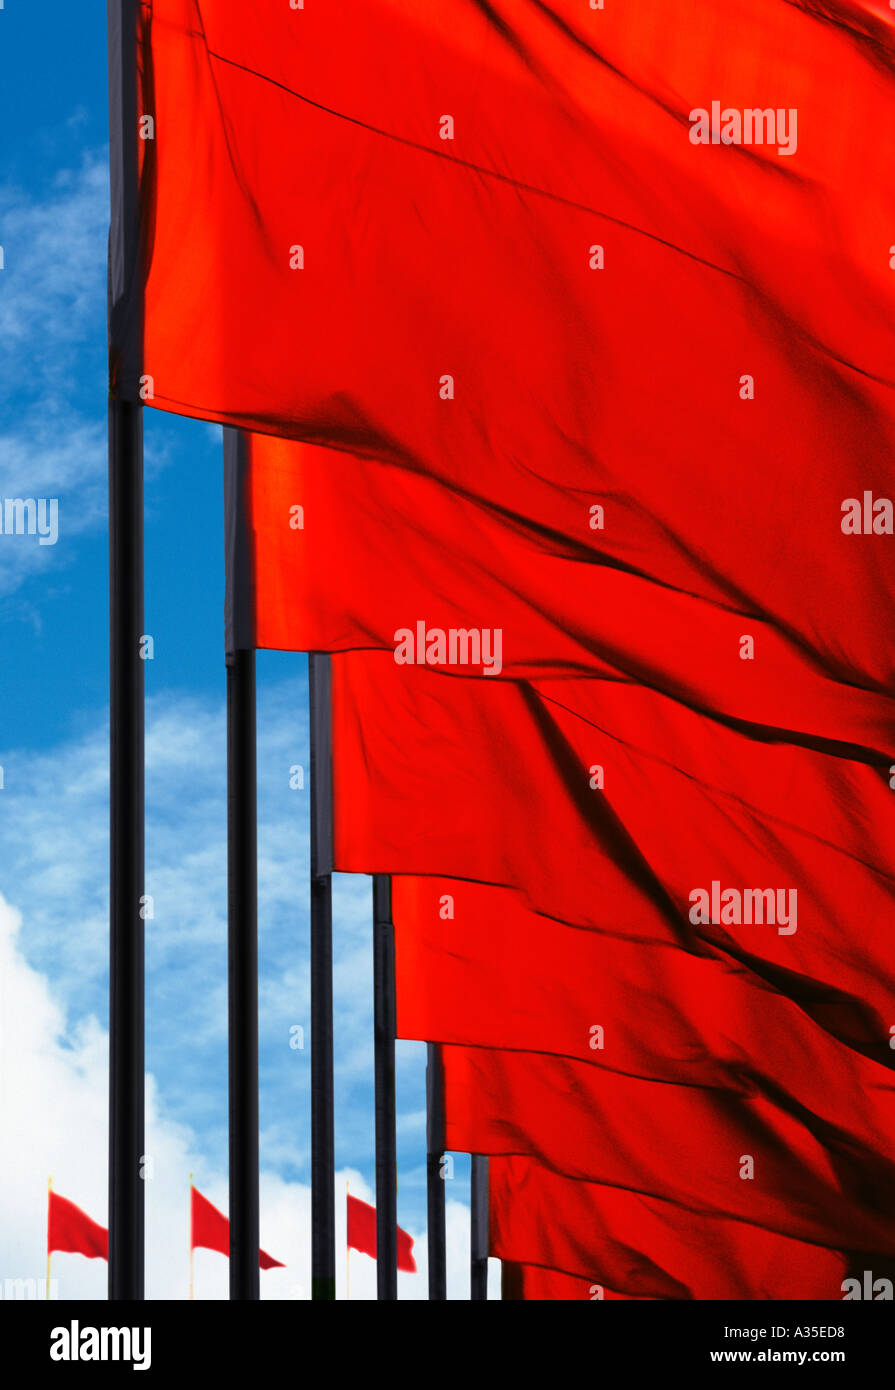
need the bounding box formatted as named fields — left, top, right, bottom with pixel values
left=0, top=0, right=467, bottom=1297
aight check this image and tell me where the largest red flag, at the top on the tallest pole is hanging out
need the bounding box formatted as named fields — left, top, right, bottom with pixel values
left=127, top=8, right=895, bottom=611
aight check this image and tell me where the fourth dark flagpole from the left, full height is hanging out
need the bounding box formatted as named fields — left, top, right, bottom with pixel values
left=372, top=873, right=397, bottom=1298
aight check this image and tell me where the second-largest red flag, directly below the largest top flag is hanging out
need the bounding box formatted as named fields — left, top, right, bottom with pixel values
left=249, top=436, right=895, bottom=748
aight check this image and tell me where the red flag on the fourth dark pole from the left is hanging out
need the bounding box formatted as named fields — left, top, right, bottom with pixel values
left=392, top=877, right=895, bottom=1154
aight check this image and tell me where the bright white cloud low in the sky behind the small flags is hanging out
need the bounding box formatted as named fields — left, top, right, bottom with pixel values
left=0, top=898, right=483, bottom=1300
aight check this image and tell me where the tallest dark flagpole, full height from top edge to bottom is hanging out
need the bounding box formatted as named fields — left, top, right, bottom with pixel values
left=107, top=0, right=145, bottom=1301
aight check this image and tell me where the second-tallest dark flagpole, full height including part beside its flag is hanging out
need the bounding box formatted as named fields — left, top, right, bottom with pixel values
left=224, top=428, right=261, bottom=1300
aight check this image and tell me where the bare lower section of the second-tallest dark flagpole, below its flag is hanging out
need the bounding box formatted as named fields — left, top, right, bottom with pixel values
left=227, top=651, right=260, bottom=1300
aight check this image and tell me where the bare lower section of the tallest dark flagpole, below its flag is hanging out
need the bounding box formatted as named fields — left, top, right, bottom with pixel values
left=108, top=400, right=146, bottom=1301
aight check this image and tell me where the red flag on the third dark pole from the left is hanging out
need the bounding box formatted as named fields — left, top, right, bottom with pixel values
left=332, top=653, right=895, bottom=1066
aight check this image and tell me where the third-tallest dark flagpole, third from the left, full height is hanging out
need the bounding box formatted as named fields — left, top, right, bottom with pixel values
left=307, top=652, right=335, bottom=1300
